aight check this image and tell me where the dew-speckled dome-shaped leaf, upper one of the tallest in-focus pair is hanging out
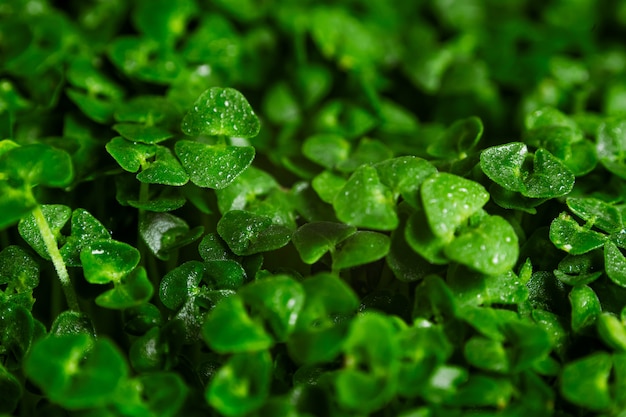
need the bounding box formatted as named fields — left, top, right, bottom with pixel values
left=181, top=87, right=261, bottom=138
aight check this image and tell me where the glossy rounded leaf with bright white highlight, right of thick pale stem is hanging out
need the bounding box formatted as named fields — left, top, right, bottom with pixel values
left=80, top=239, right=140, bottom=284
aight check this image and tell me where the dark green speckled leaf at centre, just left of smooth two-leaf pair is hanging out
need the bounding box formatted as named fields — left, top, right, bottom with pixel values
left=217, top=210, right=291, bottom=256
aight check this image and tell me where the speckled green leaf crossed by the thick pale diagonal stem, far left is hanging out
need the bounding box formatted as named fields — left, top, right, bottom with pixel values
left=17, top=204, right=72, bottom=260
